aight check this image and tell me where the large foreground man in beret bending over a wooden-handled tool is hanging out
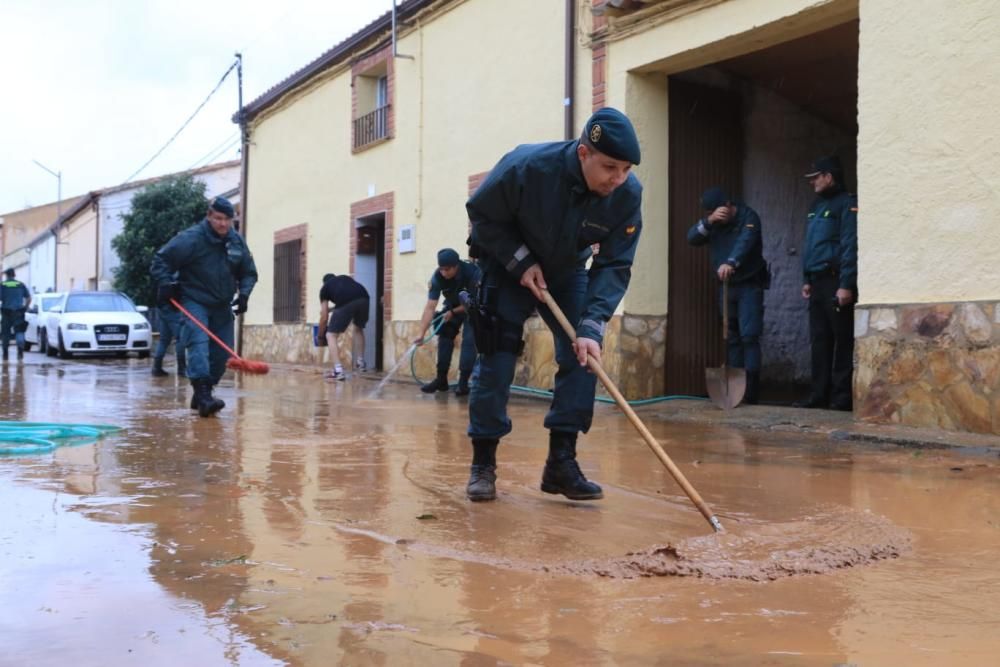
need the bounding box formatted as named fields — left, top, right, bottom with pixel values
left=466, top=108, right=642, bottom=501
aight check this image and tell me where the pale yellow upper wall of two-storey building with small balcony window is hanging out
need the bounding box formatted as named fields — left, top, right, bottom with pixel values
left=247, top=0, right=568, bottom=324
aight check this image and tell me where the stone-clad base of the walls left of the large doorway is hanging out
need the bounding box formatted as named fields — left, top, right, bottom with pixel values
left=243, top=315, right=666, bottom=400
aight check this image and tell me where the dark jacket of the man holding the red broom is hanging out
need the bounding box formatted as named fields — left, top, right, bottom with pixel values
left=150, top=220, right=257, bottom=307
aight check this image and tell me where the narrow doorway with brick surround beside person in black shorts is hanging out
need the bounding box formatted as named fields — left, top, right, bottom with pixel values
left=354, top=213, right=385, bottom=370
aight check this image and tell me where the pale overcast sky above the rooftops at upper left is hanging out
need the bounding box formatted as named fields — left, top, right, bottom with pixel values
left=0, top=0, right=392, bottom=213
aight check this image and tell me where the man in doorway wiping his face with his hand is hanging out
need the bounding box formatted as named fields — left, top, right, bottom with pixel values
left=688, top=187, right=768, bottom=405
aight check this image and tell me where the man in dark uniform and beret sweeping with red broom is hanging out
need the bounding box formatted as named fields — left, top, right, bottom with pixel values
left=150, top=197, right=257, bottom=417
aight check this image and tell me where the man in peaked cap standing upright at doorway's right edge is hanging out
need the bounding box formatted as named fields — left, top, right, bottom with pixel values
left=796, top=157, right=858, bottom=411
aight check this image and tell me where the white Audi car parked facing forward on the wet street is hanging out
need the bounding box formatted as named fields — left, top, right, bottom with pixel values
left=45, top=292, right=153, bottom=359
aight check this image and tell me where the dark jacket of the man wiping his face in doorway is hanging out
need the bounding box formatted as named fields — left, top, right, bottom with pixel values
left=688, top=204, right=766, bottom=283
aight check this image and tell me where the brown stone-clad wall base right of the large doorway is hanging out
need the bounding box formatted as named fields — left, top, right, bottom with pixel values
left=854, top=302, right=1000, bottom=434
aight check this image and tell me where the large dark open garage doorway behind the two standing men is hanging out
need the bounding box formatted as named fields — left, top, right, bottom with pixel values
left=665, top=20, right=858, bottom=403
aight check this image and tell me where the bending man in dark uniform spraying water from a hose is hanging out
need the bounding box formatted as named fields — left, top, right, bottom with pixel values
left=413, top=248, right=480, bottom=396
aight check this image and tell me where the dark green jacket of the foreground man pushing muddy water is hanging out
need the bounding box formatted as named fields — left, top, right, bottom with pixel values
left=466, top=141, right=642, bottom=342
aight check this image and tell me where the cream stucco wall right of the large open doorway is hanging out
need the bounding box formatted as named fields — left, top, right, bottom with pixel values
left=858, top=0, right=1000, bottom=304
